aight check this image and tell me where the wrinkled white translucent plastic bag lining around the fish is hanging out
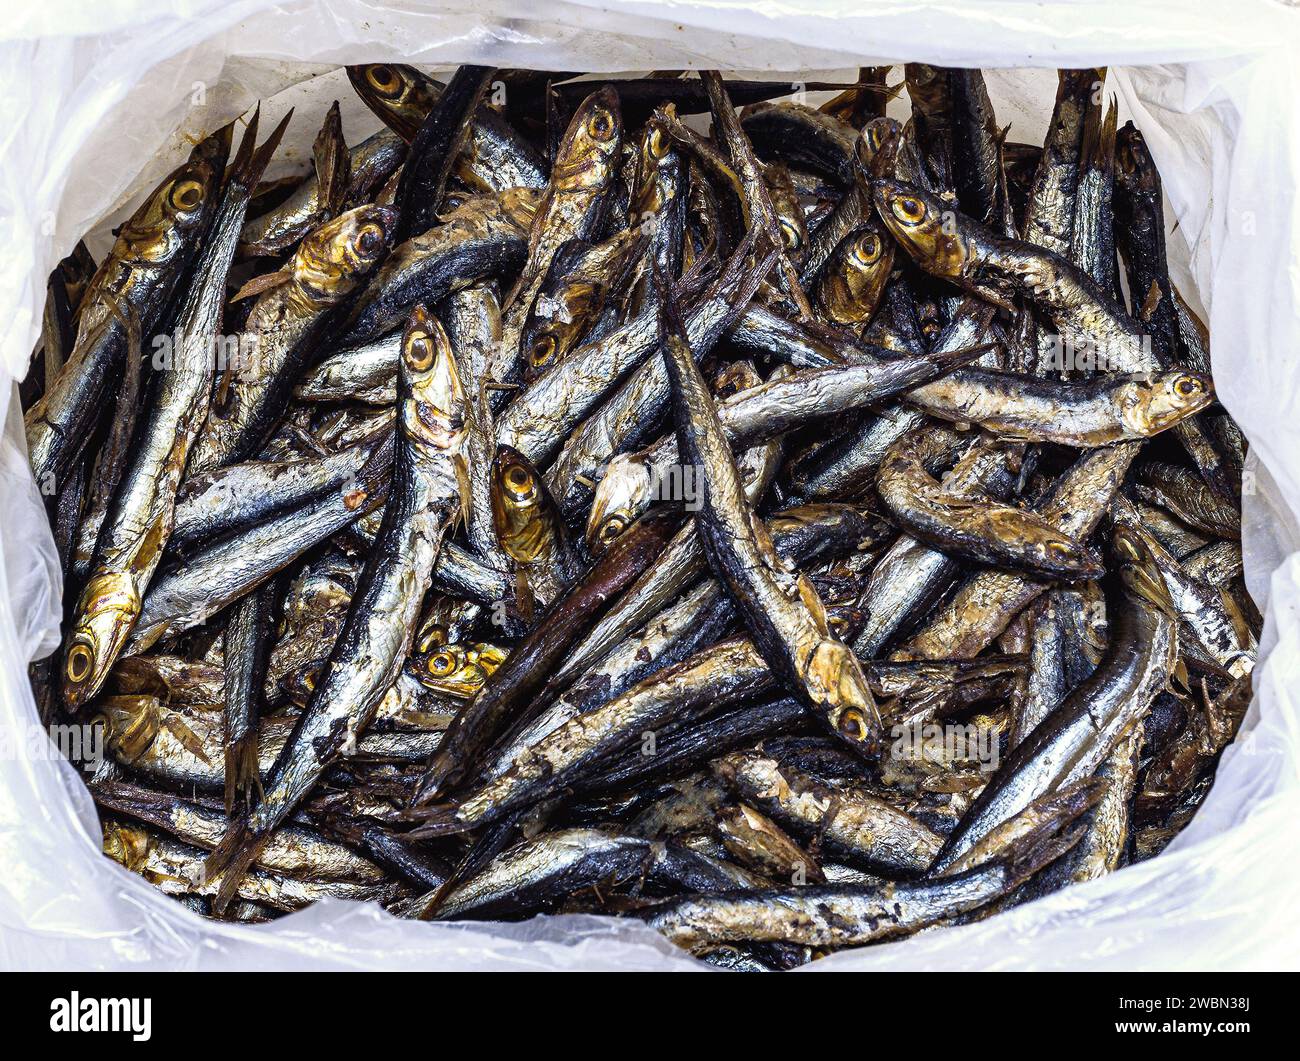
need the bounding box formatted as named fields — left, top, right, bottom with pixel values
left=0, top=0, right=1300, bottom=970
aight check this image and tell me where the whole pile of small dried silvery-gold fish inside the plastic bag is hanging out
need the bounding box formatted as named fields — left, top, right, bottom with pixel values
left=23, top=64, right=1261, bottom=969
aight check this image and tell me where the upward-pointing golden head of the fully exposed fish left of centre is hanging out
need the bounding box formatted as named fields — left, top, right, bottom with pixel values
left=398, top=306, right=465, bottom=452
